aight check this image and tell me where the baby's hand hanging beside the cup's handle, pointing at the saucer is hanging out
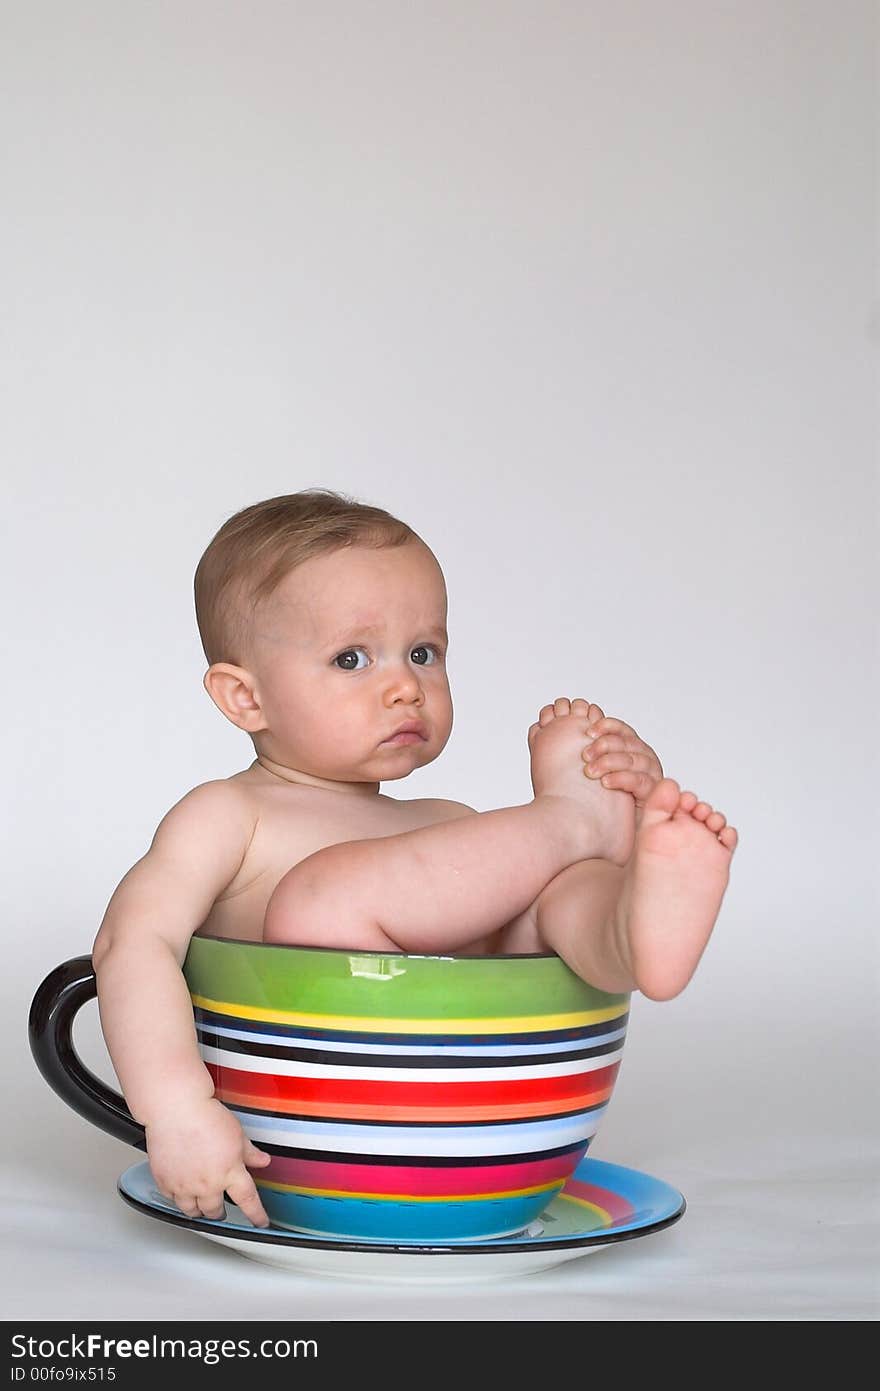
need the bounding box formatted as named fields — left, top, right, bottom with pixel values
left=146, top=1097, right=271, bottom=1227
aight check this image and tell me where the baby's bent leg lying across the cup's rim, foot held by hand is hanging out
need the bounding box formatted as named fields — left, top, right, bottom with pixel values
left=263, top=715, right=635, bottom=953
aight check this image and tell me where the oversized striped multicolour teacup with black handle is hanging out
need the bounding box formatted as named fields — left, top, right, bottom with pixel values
left=31, top=938, right=628, bottom=1244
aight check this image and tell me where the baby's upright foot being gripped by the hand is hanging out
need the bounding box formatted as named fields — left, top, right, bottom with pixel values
left=528, top=698, right=635, bottom=865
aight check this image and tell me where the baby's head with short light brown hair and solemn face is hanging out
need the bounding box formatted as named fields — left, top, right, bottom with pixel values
left=195, top=488, right=452, bottom=790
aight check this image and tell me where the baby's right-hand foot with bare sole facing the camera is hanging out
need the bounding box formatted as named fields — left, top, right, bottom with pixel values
left=617, top=778, right=738, bottom=1000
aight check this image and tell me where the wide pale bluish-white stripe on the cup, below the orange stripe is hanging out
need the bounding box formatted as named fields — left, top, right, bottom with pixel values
left=234, top=1106, right=606, bottom=1156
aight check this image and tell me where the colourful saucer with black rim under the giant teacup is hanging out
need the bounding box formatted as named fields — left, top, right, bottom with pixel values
left=117, top=1159, right=685, bottom=1284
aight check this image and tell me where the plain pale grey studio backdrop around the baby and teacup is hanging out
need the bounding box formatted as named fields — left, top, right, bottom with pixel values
left=0, top=0, right=879, bottom=1320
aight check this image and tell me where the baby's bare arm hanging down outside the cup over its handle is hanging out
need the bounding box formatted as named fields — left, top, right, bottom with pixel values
left=92, top=782, right=270, bottom=1225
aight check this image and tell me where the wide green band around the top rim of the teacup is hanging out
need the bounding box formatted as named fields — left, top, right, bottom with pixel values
left=184, top=938, right=628, bottom=1020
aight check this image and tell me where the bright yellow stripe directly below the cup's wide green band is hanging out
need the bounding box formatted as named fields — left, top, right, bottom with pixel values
left=192, top=995, right=626, bottom=1034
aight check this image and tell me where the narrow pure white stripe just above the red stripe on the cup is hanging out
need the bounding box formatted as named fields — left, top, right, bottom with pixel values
left=199, top=1043, right=623, bottom=1082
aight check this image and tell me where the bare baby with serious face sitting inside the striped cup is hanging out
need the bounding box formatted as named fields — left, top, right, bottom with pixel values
left=93, top=490, right=737, bottom=1225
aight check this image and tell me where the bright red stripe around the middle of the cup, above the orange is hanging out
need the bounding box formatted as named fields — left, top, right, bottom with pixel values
left=207, top=1063, right=620, bottom=1114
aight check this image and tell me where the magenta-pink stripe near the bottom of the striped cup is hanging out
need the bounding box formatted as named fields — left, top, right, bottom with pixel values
left=261, top=1149, right=584, bottom=1196
